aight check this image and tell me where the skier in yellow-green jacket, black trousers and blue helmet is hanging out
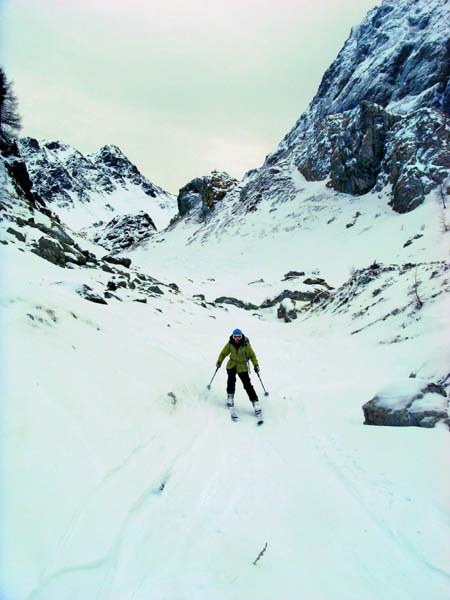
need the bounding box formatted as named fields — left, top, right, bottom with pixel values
left=216, top=329, right=262, bottom=424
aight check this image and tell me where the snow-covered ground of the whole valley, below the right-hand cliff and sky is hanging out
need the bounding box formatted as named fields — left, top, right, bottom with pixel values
left=0, top=0, right=450, bottom=600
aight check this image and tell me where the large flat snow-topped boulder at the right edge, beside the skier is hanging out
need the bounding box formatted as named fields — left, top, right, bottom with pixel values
left=362, top=378, right=450, bottom=427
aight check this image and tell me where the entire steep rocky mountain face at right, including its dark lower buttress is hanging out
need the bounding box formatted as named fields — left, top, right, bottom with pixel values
left=240, top=0, right=450, bottom=212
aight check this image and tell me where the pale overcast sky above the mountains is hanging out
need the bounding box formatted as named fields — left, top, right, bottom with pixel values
left=0, top=0, right=380, bottom=193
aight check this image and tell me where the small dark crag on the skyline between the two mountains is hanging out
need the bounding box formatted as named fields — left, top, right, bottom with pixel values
left=177, top=171, right=237, bottom=216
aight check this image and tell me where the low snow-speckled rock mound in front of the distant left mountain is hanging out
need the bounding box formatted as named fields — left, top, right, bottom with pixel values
left=92, top=212, right=156, bottom=252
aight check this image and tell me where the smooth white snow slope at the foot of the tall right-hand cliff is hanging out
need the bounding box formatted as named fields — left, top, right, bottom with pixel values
left=127, top=175, right=450, bottom=304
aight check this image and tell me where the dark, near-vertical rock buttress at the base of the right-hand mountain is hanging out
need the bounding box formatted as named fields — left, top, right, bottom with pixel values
left=296, top=102, right=450, bottom=212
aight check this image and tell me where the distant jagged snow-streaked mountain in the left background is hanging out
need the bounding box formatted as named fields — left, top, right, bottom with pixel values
left=15, top=138, right=176, bottom=244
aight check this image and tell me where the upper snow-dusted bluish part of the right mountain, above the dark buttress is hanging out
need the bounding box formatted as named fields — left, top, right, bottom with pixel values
left=285, top=0, right=450, bottom=152
